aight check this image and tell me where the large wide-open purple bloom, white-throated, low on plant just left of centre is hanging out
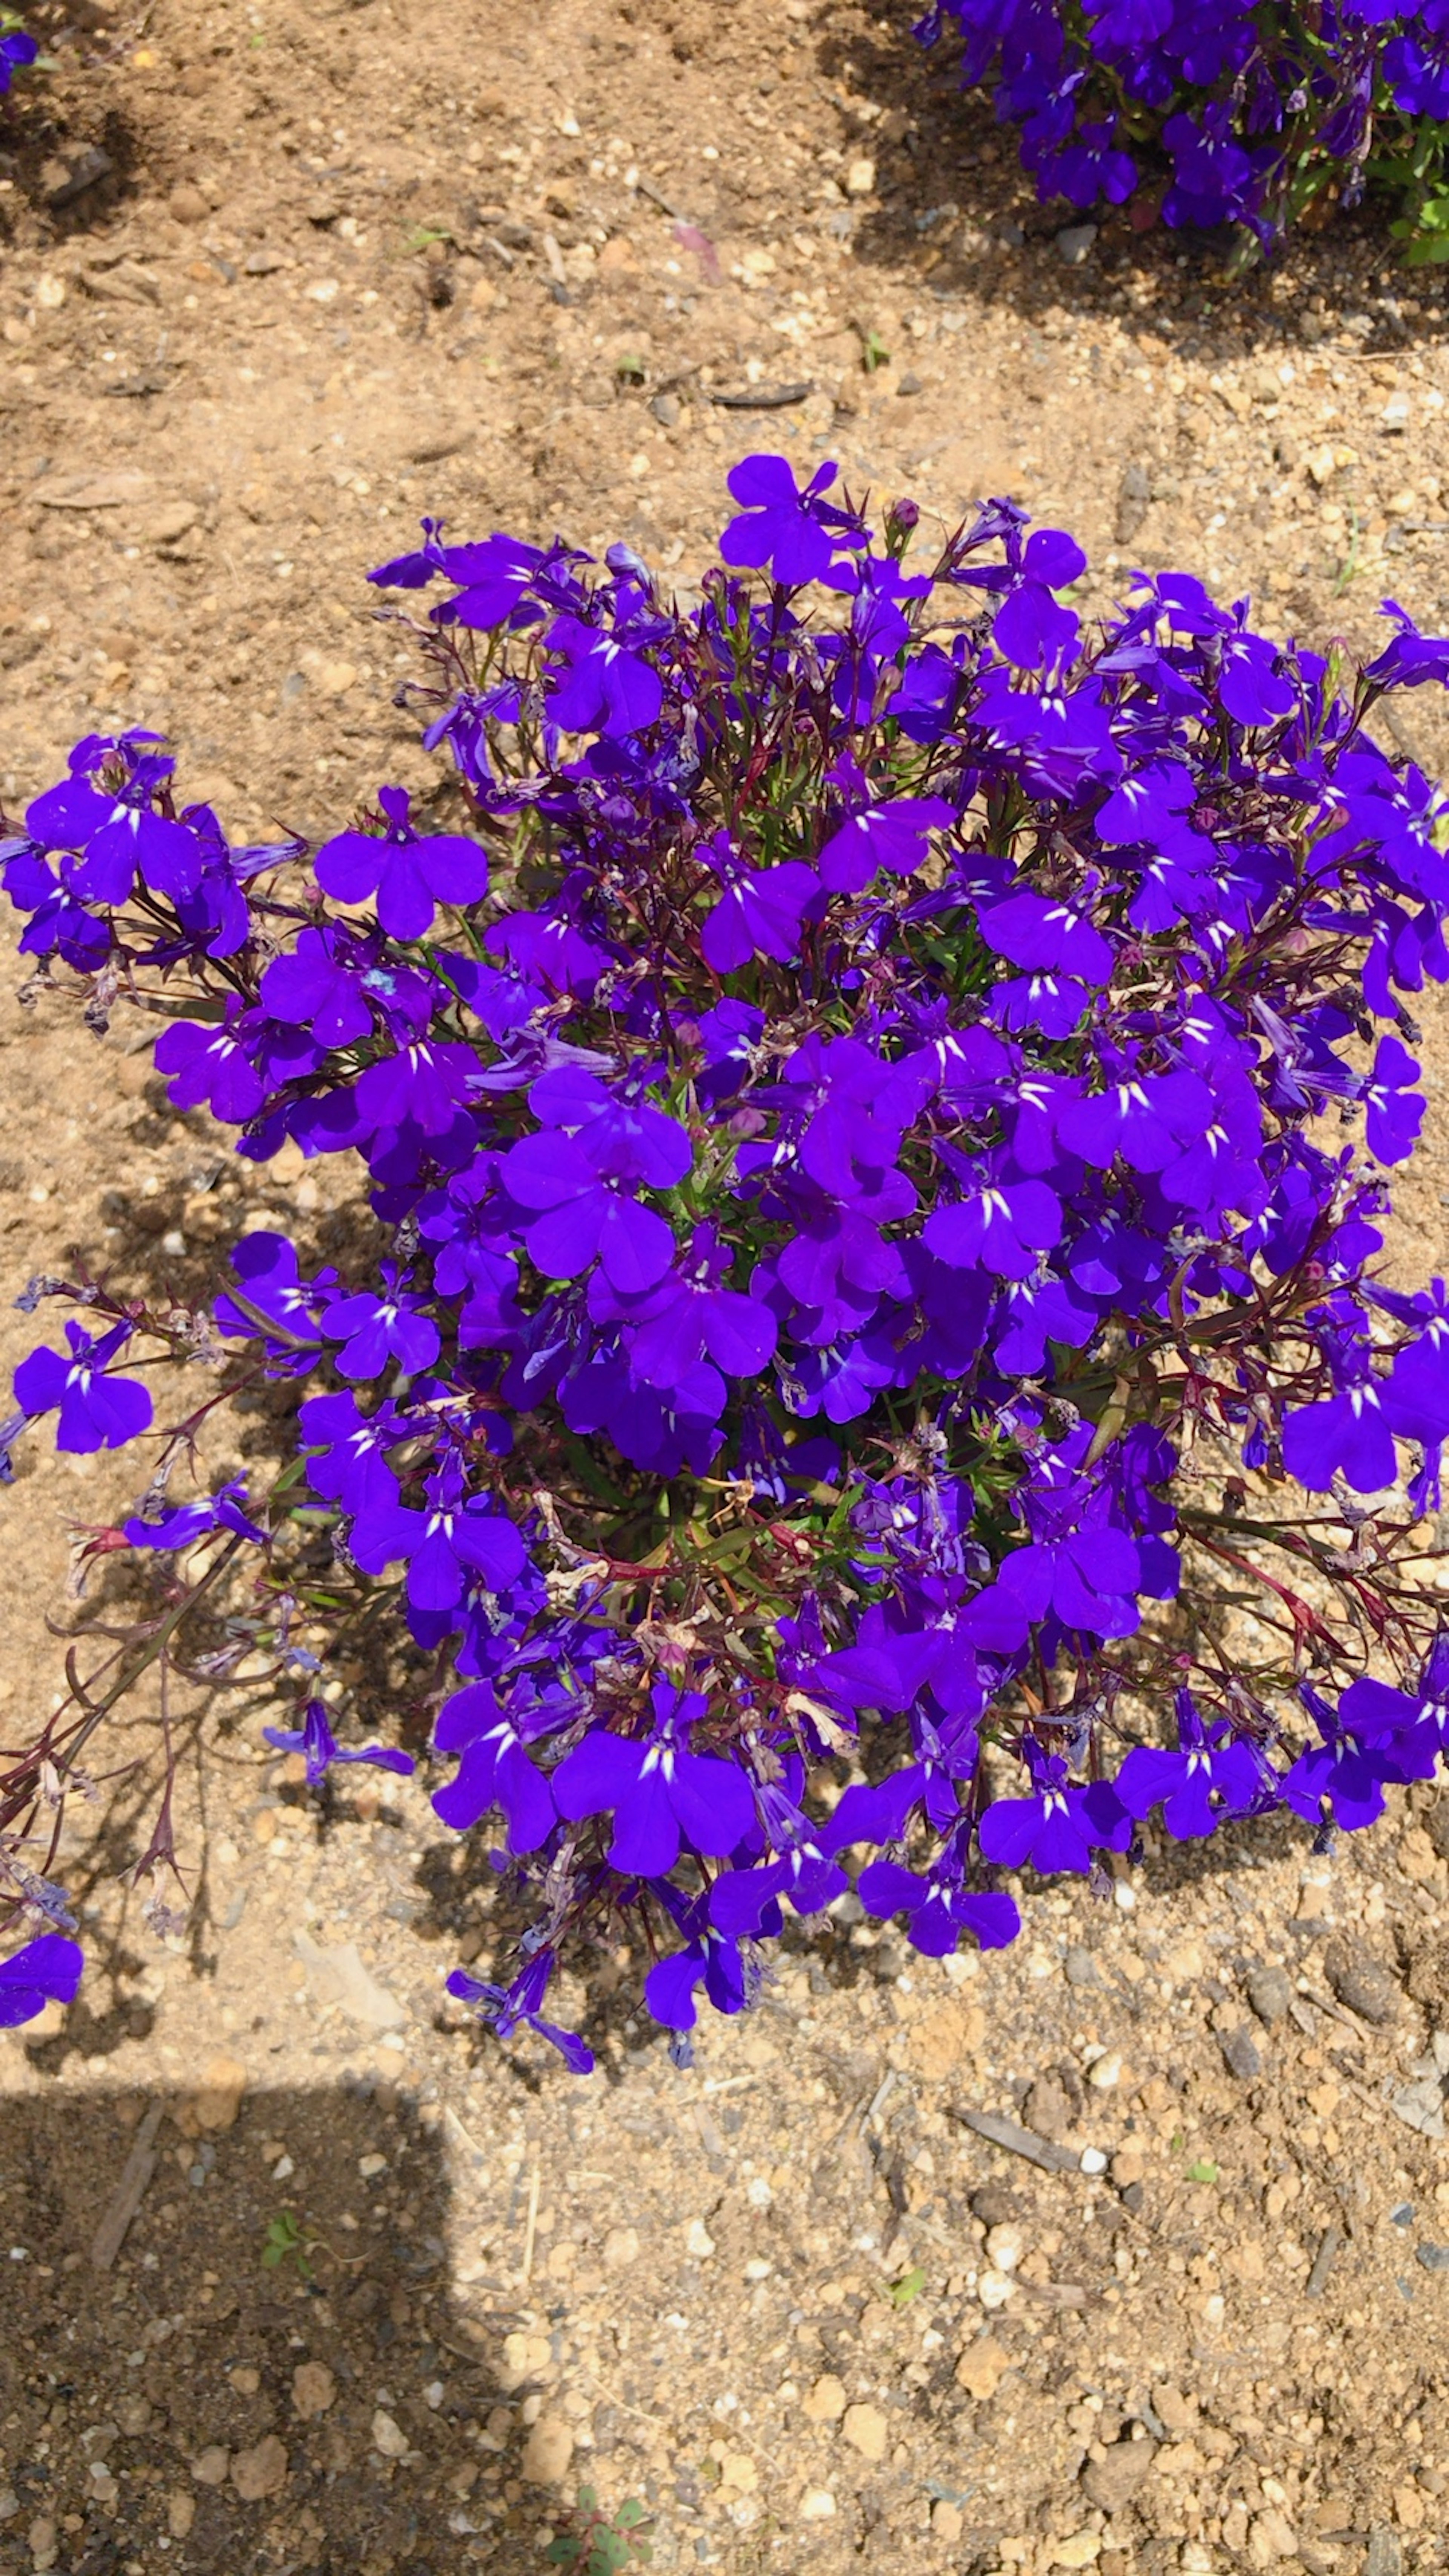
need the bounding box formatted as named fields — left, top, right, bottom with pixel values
left=552, top=1682, right=755, bottom=1878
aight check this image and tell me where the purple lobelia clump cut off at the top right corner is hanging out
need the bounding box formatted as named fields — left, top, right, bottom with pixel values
left=915, top=0, right=1449, bottom=255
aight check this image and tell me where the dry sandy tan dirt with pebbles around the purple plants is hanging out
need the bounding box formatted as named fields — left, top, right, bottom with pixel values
left=0, top=0, right=1449, bottom=2576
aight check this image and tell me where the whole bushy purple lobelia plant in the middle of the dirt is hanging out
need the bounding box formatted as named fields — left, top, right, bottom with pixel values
left=0, top=456, right=1449, bottom=2068
